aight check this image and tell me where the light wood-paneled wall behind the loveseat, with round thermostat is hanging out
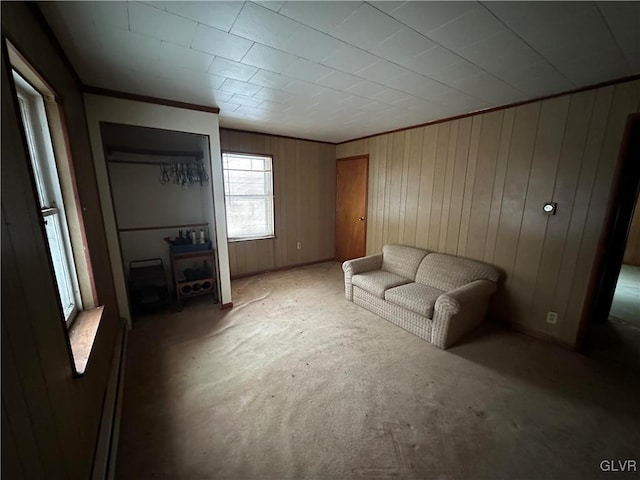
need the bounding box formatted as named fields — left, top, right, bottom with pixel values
left=337, top=81, right=640, bottom=345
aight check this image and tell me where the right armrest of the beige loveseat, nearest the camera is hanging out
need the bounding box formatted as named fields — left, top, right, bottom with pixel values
left=431, top=280, right=498, bottom=348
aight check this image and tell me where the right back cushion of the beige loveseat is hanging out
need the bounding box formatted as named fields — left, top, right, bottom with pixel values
left=415, top=253, right=500, bottom=292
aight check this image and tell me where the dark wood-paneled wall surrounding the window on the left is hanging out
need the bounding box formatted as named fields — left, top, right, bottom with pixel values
left=1, top=2, right=122, bottom=479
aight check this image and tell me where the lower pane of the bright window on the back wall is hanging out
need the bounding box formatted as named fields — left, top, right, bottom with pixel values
left=227, top=196, right=273, bottom=238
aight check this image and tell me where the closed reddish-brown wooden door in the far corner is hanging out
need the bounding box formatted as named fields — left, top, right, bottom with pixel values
left=336, top=155, right=369, bottom=262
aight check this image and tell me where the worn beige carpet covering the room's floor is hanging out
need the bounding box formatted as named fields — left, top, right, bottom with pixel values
left=116, top=262, right=640, bottom=480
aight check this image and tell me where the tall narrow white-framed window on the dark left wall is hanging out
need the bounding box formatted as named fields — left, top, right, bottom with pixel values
left=13, top=72, right=82, bottom=324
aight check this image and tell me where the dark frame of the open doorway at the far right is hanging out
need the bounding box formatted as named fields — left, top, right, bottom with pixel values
left=576, top=113, right=640, bottom=351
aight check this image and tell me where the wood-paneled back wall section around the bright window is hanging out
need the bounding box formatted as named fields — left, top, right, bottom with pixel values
left=220, top=128, right=336, bottom=276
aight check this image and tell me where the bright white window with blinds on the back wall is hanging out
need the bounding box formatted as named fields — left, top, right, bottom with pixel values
left=222, top=153, right=274, bottom=241
